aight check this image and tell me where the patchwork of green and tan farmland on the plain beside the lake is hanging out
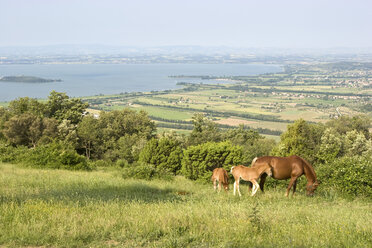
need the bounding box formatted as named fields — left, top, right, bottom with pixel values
left=85, top=63, right=372, bottom=138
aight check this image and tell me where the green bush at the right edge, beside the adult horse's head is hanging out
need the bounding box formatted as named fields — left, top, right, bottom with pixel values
left=317, top=156, right=372, bottom=197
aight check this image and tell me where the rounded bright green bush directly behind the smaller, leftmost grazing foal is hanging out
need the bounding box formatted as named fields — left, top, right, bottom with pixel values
left=182, top=141, right=242, bottom=181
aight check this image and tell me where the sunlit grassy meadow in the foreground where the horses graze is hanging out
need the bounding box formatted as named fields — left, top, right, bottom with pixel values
left=0, top=163, right=372, bottom=247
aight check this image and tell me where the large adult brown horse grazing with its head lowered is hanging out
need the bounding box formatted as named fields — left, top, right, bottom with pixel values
left=252, top=155, right=319, bottom=196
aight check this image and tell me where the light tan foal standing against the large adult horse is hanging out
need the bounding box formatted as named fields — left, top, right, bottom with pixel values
left=230, top=164, right=271, bottom=196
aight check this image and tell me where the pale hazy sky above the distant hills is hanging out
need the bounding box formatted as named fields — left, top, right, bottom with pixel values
left=0, top=0, right=372, bottom=48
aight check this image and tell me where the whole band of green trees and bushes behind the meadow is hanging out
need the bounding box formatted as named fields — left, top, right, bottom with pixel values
left=0, top=92, right=372, bottom=197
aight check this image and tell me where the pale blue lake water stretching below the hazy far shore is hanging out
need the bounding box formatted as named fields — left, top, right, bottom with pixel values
left=0, top=64, right=283, bottom=102
